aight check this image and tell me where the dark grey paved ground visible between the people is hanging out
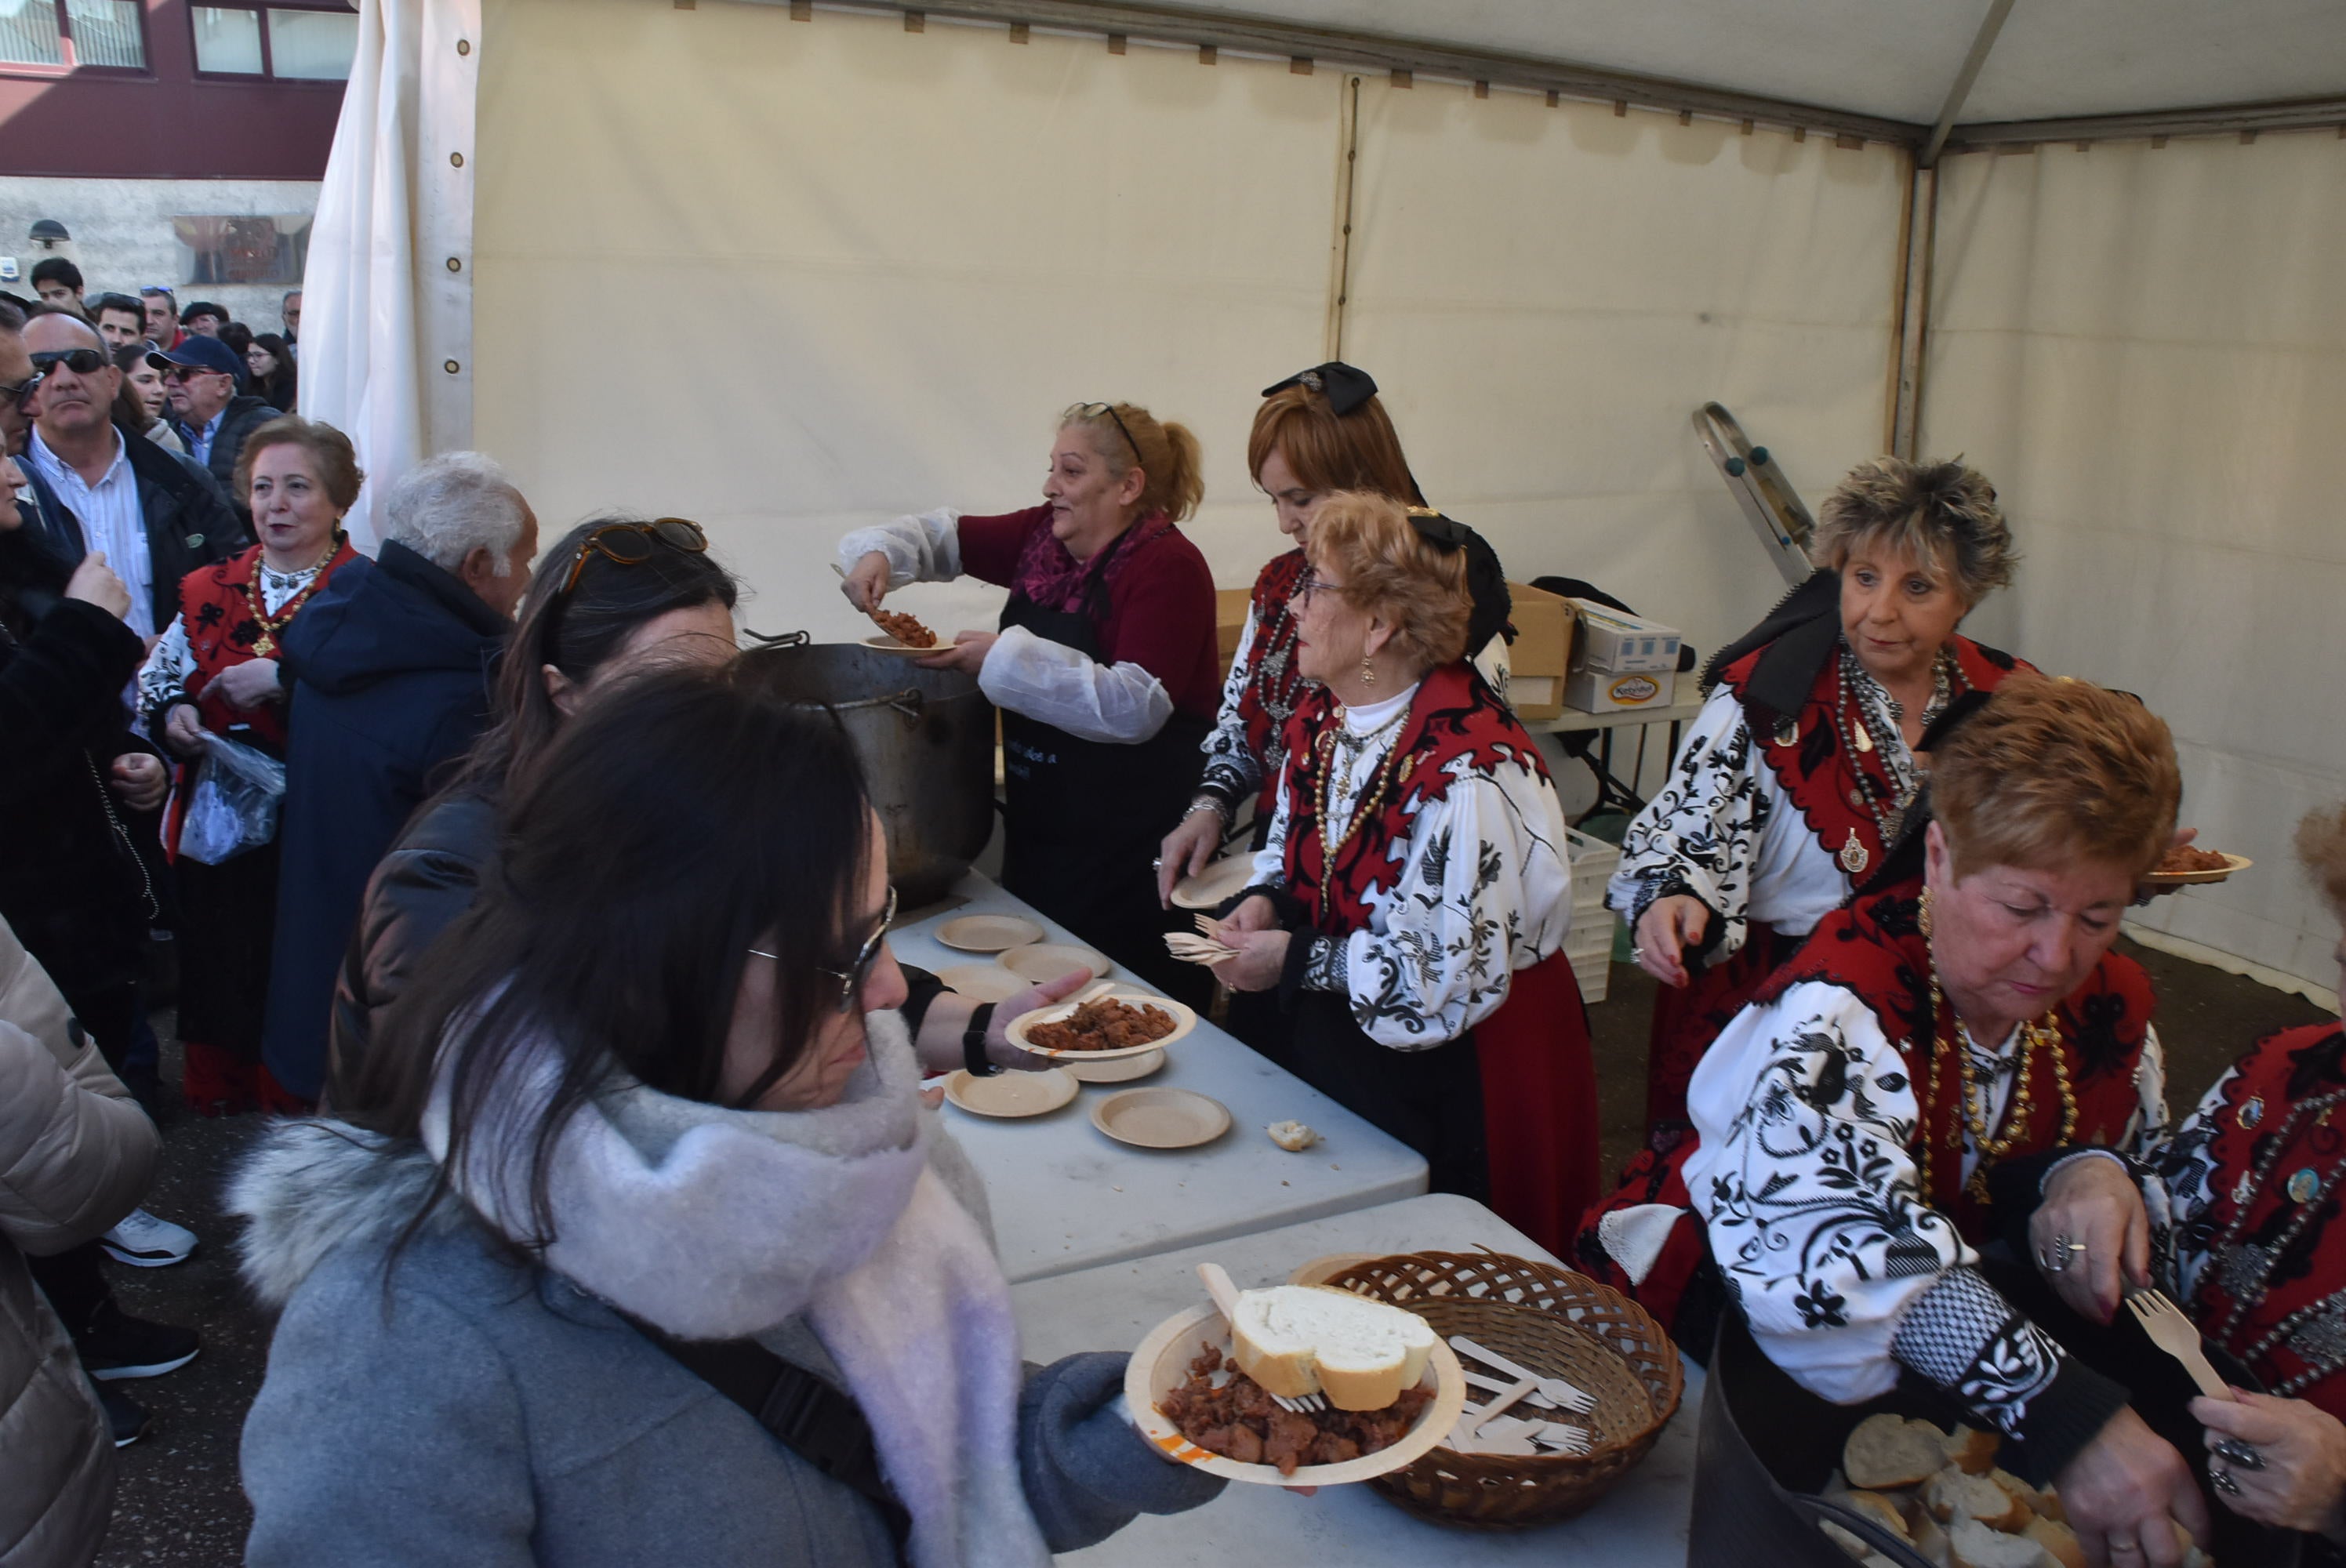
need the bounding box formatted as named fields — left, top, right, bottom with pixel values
left=99, top=944, right=2325, bottom=1568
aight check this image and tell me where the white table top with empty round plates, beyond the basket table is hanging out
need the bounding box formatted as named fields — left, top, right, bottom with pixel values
left=889, top=873, right=1426, bottom=1286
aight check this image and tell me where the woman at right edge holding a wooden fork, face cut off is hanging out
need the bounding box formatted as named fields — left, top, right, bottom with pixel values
left=2029, top=808, right=2346, bottom=1561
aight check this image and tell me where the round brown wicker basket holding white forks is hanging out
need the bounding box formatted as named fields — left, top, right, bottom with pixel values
left=1325, top=1251, right=1687, bottom=1530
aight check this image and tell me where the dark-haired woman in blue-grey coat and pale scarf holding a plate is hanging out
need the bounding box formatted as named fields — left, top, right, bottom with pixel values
left=232, top=666, right=1220, bottom=1568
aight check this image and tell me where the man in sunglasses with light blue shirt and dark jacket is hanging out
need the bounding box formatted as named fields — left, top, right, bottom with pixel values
left=24, top=314, right=251, bottom=636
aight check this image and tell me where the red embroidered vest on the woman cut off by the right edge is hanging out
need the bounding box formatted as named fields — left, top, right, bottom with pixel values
left=2192, top=1023, right=2346, bottom=1420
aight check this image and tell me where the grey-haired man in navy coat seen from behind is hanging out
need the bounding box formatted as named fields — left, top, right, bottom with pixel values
left=263, top=453, right=537, bottom=1108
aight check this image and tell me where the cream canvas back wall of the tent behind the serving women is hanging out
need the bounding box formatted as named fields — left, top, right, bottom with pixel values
left=471, top=0, right=1903, bottom=662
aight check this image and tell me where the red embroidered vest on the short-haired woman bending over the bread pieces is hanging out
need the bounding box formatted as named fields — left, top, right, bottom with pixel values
left=1752, top=878, right=2154, bottom=1244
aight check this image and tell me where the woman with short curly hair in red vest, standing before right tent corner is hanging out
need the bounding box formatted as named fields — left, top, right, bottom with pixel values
left=1607, top=458, right=2015, bottom=1155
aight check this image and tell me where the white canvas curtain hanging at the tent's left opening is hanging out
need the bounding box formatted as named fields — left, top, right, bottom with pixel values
left=300, top=0, right=481, bottom=550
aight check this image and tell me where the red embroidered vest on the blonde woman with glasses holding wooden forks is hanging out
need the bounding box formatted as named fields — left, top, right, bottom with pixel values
left=1286, top=664, right=1549, bottom=937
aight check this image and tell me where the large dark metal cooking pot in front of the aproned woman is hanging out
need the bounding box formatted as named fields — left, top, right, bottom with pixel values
left=741, top=641, right=995, bottom=909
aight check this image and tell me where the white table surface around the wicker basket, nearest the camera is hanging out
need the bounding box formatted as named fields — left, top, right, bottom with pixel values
left=1011, top=1192, right=1703, bottom=1568
